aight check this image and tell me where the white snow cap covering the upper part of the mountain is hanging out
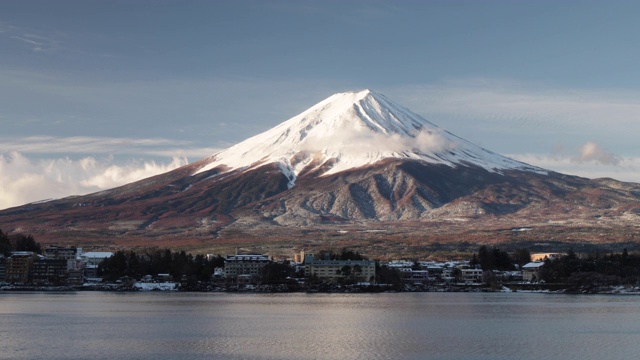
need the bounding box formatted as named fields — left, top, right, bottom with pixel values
left=198, top=90, right=543, bottom=187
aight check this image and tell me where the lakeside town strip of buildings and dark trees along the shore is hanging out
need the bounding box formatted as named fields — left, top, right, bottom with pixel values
left=0, top=230, right=640, bottom=294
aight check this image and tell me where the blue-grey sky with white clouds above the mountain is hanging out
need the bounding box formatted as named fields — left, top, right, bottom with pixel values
left=0, top=0, right=640, bottom=209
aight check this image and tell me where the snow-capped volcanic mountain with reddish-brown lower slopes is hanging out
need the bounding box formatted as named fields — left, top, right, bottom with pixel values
left=0, top=90, right=640, bottom=250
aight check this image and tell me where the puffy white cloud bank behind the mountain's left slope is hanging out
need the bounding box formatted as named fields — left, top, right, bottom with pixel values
left=0, top=152, right=188, bottom=209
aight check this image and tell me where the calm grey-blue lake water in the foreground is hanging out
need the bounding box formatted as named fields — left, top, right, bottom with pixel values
left=0, top=292, right=640, bottom=360
